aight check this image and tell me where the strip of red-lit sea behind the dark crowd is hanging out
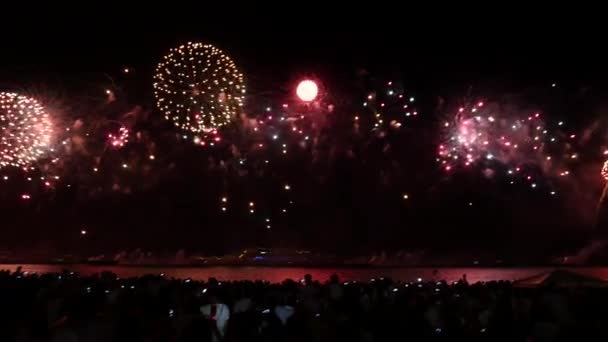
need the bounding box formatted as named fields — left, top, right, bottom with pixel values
left=0, top=264, right=608, bottom=283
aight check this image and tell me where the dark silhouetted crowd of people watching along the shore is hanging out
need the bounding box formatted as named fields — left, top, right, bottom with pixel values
left=0, top=269, right=608, bottom=342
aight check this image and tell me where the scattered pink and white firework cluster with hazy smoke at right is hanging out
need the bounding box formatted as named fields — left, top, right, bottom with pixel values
left=437, top=101, right=579, bottom=194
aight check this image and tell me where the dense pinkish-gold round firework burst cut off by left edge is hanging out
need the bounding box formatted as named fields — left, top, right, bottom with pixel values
left=0, top=93, right=53, bottom=167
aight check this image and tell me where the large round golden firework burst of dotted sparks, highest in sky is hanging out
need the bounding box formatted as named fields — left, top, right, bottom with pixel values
left=154, top=42, right=245, bottom=134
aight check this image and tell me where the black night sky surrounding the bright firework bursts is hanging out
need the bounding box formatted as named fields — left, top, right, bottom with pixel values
left=0, top=4, right=608, bottom=253
